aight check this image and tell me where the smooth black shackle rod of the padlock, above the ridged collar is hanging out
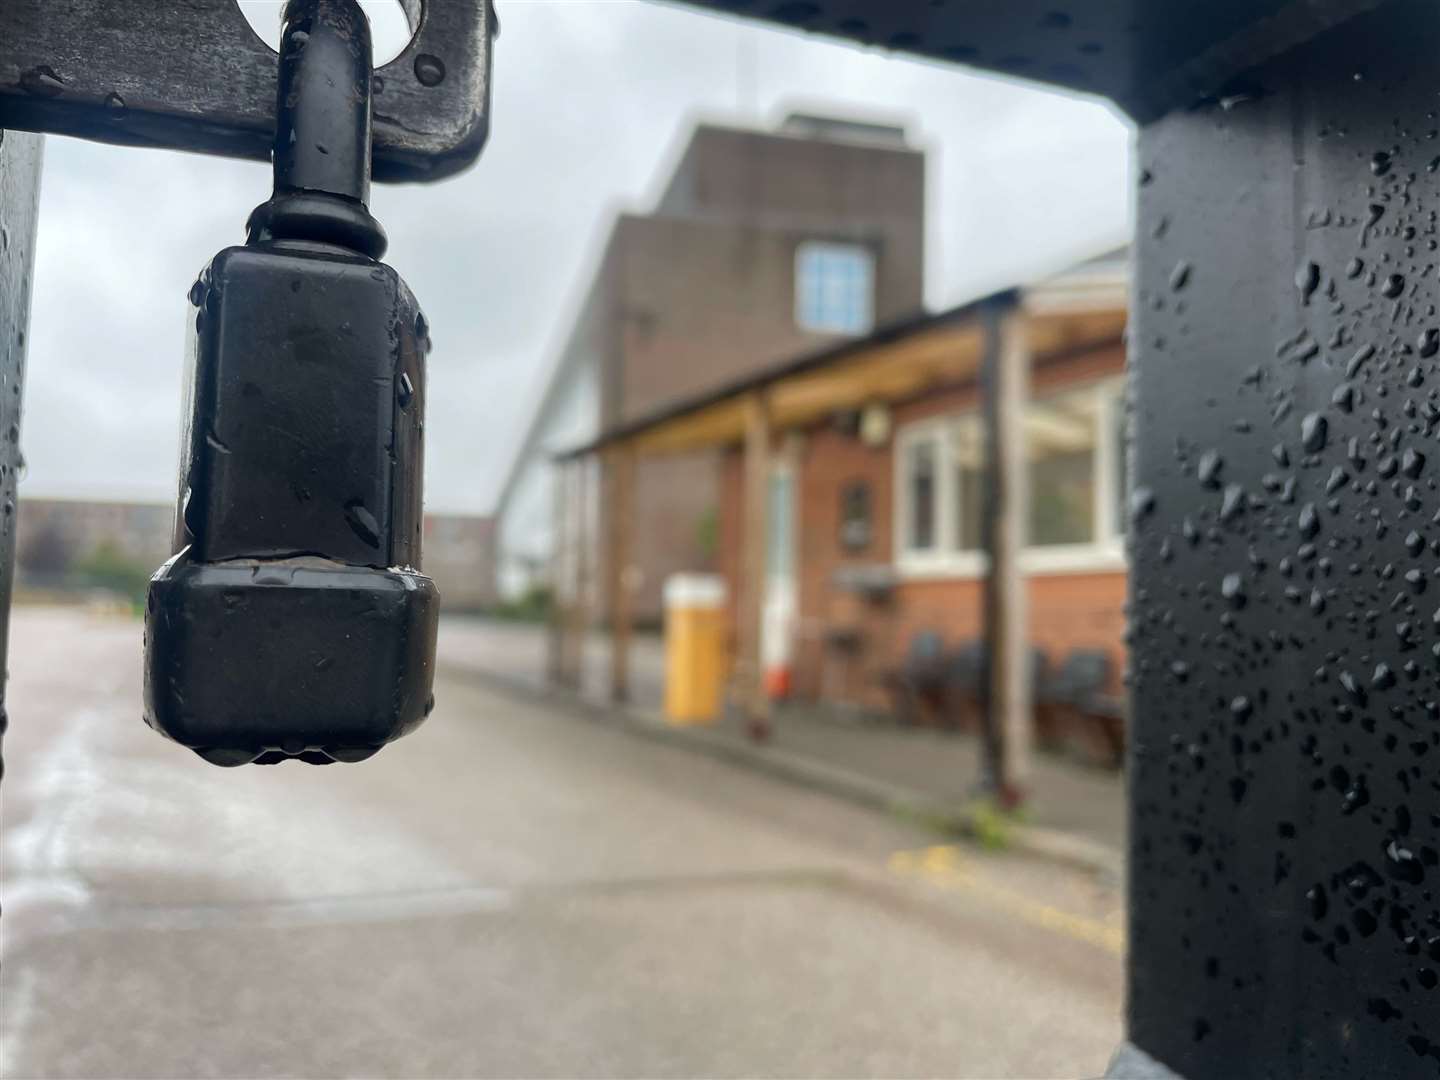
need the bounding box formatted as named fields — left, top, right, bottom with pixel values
left=274, top=0, right=373, bottom=203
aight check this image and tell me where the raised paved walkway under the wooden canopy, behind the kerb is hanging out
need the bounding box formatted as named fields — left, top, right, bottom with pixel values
left=439, top=618, right=1126, bottom=852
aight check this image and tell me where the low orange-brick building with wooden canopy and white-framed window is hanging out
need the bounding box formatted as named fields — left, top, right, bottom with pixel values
left=562, top=252, right=1128, bottom=737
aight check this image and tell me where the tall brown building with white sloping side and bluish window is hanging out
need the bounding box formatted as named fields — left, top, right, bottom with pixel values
left=495, top=115, right=924, bottom=618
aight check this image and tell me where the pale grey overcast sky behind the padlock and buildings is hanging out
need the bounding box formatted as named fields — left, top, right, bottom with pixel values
left=22, top=0, right=1130, bottom=513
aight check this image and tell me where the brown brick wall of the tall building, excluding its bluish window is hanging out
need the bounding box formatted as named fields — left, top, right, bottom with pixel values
left=547, top=125, right=926, bottom=621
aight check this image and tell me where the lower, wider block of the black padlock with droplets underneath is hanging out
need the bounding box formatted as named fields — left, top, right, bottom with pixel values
left=145, top=552, right=439, bottom=765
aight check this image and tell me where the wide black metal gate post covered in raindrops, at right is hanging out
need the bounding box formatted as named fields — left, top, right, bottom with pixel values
left=1115, top=0, right=1440, bottom=1080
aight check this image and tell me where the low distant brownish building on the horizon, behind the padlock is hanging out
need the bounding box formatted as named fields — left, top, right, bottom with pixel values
left=16, top=498, right=495, bottom=612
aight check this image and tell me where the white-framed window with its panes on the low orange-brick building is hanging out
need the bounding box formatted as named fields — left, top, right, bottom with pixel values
left=896, top=379, right=1126, bottom=575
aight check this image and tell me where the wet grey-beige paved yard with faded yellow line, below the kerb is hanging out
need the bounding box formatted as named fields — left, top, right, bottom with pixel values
left=0, top=608, right=1122, bottom=1077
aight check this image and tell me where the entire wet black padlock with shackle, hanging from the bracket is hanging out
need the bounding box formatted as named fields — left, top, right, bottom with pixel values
left=145, top=0, right=439, bottom=765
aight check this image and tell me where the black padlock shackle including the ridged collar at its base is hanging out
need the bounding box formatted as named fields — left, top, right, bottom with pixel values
left=249, top=0, right=386, bottom=259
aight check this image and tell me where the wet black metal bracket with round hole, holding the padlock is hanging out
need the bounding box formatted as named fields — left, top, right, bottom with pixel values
left=0, top=0, right=497, bottom=181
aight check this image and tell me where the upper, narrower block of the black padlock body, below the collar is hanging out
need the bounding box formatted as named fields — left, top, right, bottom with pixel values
left=176, top=243, right=426, bottom=566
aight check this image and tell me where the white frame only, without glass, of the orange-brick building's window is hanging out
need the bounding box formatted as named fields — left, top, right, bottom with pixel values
left=891, top=376, right=1128, bottom=577
